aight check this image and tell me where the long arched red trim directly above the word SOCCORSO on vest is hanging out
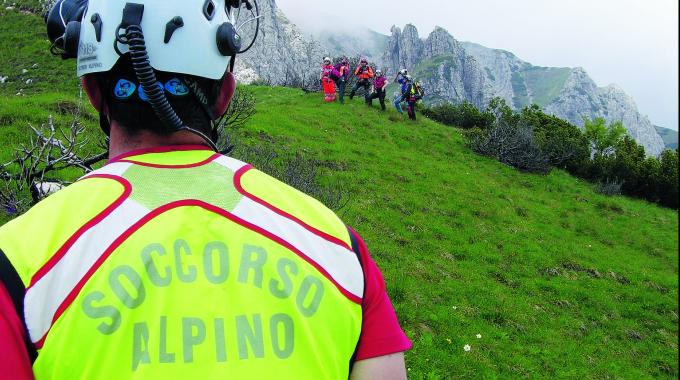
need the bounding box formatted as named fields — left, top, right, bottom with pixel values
left=35, top=200, right=362, bottom=349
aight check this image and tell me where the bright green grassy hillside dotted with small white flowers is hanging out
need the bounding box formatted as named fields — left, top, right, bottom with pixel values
left=0, top=5, right=678, bottom=379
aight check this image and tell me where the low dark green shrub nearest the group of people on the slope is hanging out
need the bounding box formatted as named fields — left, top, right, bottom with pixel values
left=422, top=101, right=494, bottom=129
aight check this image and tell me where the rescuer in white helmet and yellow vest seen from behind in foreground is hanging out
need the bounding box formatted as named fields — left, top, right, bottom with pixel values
left=0, top=0, right=411, bottom=380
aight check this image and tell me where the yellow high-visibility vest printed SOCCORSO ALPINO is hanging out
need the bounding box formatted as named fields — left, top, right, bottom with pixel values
left=0, top=148, right=364, bottom=379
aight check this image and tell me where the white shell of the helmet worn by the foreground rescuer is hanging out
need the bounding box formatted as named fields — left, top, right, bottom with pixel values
left=77, top=0, right=233, bottom=79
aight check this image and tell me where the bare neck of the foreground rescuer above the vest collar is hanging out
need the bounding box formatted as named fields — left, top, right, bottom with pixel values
left=109, top=123, right=208, bottom=159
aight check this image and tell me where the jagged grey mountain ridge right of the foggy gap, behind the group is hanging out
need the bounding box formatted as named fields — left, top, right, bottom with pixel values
left=383, top=24, right=664, bottom=156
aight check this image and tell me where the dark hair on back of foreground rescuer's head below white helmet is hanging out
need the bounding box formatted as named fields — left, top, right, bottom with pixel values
left=94, top=55, right=222, bottom=136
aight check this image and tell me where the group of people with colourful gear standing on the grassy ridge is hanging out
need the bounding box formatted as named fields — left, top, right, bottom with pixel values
left=320, top=57, right=423, bottom=120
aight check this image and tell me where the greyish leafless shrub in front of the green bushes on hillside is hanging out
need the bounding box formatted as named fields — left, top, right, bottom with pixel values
left=468, top=120, right=550, bottom=173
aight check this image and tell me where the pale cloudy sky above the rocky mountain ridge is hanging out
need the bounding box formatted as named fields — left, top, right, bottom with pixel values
left=276, top=0, right=678, bottom=130
